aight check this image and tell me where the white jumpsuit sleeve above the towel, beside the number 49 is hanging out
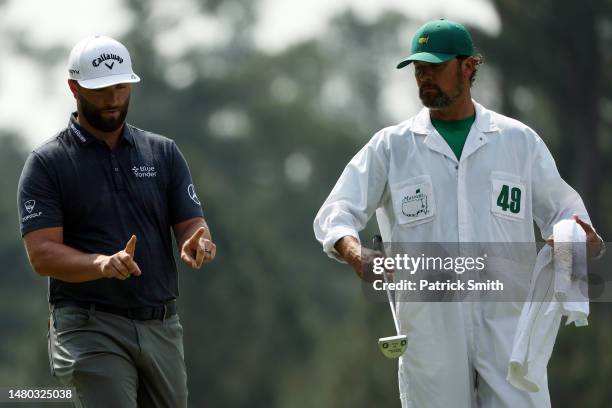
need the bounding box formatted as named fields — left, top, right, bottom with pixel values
left=531, top=131, right=591, bottom=239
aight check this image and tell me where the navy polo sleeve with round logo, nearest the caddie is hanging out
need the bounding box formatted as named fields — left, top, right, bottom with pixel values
left=168, top=142, right=203, bottom=225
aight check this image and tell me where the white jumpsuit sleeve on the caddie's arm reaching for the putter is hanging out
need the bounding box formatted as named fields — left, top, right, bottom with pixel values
left=313, top=133, right=389, bottom=262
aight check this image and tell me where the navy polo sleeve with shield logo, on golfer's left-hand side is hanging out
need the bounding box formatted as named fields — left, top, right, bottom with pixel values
left=17, top=152, right=63, bottom=236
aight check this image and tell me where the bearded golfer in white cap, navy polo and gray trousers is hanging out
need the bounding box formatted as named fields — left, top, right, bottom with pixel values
left=18, top=36, right=216, bottom=408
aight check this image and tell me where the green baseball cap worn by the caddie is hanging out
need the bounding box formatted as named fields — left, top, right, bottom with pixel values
left=397, top=18, right=474, bottom=69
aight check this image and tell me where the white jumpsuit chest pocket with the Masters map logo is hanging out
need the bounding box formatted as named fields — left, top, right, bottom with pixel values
left=390, top=175, right=436, bottom=227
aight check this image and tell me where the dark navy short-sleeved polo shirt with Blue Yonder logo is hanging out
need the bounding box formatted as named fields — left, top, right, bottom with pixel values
left=17, top=114, right=202, bottom=307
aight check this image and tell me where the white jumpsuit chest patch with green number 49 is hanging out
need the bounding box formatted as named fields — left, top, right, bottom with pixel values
left=491, top=171, right=527, bottom=221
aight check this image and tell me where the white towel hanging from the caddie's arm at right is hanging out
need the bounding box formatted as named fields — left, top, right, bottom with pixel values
left=506, top=220, right=589, bottom=392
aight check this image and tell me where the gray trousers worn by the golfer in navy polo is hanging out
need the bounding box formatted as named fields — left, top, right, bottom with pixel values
left=49, top=306, right=187, bottom=408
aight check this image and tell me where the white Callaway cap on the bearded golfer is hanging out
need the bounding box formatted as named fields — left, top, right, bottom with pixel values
left=68, top=35, right=140, bottom=89
